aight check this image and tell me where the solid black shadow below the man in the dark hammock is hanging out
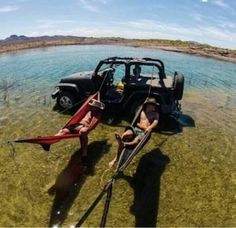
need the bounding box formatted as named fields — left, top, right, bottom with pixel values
left=122, top=148, right=170, bottom=227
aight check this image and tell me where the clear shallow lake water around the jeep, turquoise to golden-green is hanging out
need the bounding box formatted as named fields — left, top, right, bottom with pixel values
left=0, top=46, right=236, bottom=226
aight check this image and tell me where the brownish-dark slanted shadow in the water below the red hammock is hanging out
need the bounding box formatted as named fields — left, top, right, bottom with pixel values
left=48, top=140, right=110, bottom=227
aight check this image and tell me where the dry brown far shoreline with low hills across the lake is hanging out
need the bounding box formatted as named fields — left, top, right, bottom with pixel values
left=0, top=35, right=236, bottom=63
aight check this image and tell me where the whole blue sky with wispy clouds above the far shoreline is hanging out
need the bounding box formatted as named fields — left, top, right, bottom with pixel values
left=0, top=0, right=236, bottom=49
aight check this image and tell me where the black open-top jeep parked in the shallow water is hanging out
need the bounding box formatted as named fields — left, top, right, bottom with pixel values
left=52, top=57, right=184, bottom=115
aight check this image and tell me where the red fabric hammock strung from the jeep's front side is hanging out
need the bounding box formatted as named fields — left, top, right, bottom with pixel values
left=14, top=92, right=101, bottom=151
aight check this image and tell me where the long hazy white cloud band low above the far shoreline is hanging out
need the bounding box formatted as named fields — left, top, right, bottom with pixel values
left=30, top=20, right=236, bottom=49
